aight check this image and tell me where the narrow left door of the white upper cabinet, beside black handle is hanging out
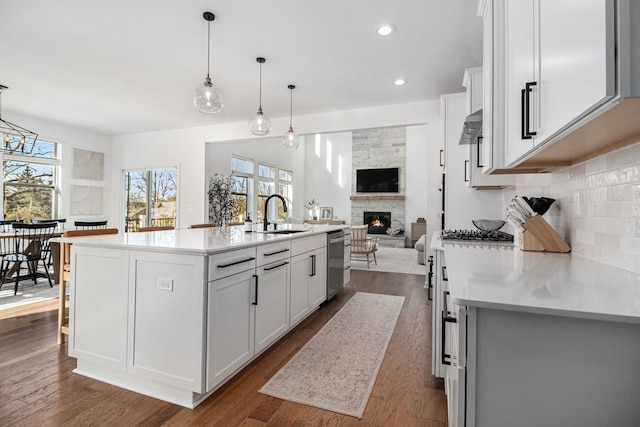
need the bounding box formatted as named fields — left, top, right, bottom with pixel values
left=504, top=0, right=539, bottom=164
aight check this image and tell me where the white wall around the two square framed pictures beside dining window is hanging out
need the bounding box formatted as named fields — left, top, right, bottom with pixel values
left=3, top=113, right=115, bottom=225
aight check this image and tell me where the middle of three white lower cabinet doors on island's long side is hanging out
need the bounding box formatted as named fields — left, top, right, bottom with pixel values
left=255, top=260, right=291, bottom=353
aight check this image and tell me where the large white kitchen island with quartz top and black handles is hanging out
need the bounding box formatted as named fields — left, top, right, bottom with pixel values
left=60, top=225, right=346, bottom=408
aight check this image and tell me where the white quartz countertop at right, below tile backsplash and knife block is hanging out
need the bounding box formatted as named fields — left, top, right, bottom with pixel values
left=432, top=239, right=640, bottom=323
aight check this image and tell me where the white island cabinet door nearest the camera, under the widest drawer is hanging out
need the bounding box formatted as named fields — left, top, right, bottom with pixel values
left=207, top=270, right=255, bottom=390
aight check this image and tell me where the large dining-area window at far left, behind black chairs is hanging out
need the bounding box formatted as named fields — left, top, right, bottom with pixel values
left=2, top=134, right=60, bottom=222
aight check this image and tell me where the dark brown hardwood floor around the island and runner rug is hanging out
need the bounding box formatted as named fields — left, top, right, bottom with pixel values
left=0, top=270, right=447, bottom=427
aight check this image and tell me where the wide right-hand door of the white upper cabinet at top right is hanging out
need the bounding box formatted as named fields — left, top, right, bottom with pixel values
left=536, top=0, right=615, bottom=141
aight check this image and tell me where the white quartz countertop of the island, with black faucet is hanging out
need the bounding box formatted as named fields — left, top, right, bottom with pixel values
left=52, top=224, right=348, bottom=255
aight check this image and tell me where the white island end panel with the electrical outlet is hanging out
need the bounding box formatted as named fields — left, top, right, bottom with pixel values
left=128, top=251, right=206, bottom=393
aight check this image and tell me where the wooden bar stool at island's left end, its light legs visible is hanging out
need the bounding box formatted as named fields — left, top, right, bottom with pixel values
left=58, top=228, right=118, bottom=344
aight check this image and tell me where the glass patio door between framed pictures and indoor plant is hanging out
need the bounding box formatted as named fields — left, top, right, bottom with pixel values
left=124, top=169, right=178, bottom=231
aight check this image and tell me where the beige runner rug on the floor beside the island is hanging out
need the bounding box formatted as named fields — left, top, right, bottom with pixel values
left=259, top=292, right=404, bottom=418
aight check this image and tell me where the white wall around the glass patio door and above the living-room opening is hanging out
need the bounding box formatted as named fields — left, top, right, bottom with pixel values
left=110, top=101, right=437, bottom=231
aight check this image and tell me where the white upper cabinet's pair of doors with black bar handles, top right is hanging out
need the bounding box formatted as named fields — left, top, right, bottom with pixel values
left=500, top=0, right=615, bottom=168
